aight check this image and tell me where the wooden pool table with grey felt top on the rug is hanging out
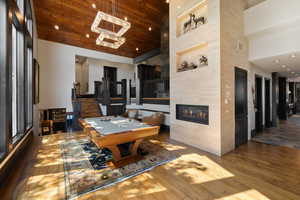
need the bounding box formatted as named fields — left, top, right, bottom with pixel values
left=79, top=116, right=160, bottom=167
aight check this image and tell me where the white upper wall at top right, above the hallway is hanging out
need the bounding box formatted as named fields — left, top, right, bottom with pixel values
left=244, top=0, right=300, bottom=61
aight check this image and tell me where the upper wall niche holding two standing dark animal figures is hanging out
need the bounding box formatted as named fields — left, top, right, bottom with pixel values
left=176, top=0, right=208, bottom=37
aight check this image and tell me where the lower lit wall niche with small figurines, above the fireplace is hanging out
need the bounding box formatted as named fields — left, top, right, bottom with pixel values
left=176, top=42, right=208, bottom=72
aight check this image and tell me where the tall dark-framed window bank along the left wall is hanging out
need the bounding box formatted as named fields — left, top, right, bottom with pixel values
left=0, top=0, right=33, bottom=161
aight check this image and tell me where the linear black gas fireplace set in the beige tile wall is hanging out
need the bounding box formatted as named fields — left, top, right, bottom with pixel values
left=176, top=104, right=209, bottom=125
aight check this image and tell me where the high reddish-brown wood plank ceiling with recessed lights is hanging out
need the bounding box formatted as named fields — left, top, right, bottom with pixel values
left=33, top=0, right=168, bottom=58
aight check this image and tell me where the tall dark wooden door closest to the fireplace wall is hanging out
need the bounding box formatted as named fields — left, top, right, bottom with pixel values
left=235, top=68, right=248, bottom=147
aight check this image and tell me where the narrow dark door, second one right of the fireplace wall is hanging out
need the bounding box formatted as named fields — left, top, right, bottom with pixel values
left=255, top=75, right=263, bottom=135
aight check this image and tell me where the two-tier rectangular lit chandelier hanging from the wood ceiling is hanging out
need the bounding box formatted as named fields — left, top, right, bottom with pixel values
left=91, top=0, right=131, bottom=49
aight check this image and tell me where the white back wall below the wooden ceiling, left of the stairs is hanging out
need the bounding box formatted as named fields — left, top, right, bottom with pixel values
left=38, top=40, right=133, bottom=111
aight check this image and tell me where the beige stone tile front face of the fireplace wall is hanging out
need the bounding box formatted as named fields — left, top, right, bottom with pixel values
left=170, top=0, right=221, bottom=155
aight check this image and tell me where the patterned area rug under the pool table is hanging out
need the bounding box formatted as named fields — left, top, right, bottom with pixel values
left=61, top=138, right=176, bottom=199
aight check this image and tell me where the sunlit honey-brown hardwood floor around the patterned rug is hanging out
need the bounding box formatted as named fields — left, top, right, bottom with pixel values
left=0, top=133, right=300, bottom=200
